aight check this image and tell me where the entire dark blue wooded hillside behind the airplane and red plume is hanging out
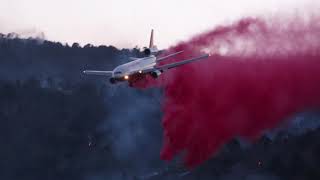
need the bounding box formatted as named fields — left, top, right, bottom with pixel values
left=0, top=34, right=320, bottom=180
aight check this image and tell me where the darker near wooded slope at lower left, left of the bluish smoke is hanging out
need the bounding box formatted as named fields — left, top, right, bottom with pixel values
left=0, top=80, right=113, bottom=179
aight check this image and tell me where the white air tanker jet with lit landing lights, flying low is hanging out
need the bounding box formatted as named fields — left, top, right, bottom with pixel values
left=83, top=29, right=209, bottom=85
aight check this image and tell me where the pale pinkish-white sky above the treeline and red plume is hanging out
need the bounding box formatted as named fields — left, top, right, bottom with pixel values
left=0, top=0, right=318, bottom=48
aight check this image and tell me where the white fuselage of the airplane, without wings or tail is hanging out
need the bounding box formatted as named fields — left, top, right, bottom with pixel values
left=112, top=55, right=157, bottom=78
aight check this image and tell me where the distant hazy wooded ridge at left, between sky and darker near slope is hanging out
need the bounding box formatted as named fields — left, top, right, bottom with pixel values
left=0, top=33, right=142, bottom=82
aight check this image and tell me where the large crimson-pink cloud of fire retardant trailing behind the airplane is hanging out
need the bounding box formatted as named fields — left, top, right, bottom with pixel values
left=131, top=17, right=320, bottom=167
